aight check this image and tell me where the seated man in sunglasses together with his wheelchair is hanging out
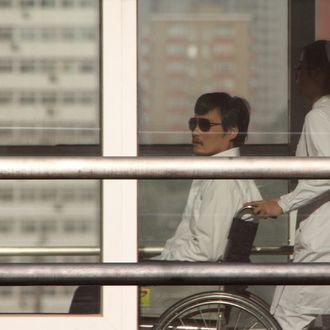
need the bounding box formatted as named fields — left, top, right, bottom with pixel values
left=148, top=93, right=280, bottom=330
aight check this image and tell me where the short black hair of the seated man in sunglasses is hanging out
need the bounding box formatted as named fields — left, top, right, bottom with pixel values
left=195, top=92, right=250, bottom=147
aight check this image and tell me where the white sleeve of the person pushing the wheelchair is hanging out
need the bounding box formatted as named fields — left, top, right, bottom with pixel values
left=279, top=111, right=330, bottom=212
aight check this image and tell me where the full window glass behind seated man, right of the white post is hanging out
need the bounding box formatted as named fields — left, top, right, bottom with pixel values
left=138, top=0, right=289, bottom=324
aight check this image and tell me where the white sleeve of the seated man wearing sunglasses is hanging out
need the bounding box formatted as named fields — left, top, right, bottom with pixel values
left=161, top=180, right=242, bottom=261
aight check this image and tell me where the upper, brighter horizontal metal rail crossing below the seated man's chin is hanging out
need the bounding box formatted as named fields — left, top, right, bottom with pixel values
left=0, top=157, right=330, bottom=179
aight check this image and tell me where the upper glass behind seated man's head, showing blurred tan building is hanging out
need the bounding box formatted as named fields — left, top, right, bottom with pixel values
left=138, top=0, right=288, bottom=144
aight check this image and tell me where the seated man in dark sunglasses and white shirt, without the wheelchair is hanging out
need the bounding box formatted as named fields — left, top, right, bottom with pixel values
left=153, top=93, right=260, bottom=261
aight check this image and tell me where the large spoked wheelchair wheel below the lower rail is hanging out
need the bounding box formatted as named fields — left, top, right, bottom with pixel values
left=154, top=291, right=281, bottom=330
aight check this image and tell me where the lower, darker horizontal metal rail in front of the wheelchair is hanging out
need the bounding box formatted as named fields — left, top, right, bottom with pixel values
left=0, top=262, right=330, bottom=285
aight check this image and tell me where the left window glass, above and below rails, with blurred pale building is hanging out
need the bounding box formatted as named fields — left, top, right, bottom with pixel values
left=0, top=0, right=101, bottom=313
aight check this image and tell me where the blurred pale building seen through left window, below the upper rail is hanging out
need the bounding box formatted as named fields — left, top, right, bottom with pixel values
left=0, top=180, right=100, bottom=313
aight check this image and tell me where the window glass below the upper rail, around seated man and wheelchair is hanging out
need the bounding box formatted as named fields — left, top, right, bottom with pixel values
left=138, top=180, right=288, bottom=324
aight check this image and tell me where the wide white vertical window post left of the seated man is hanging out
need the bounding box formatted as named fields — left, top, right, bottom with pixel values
left=102, top=0, right=137, bottom=330
